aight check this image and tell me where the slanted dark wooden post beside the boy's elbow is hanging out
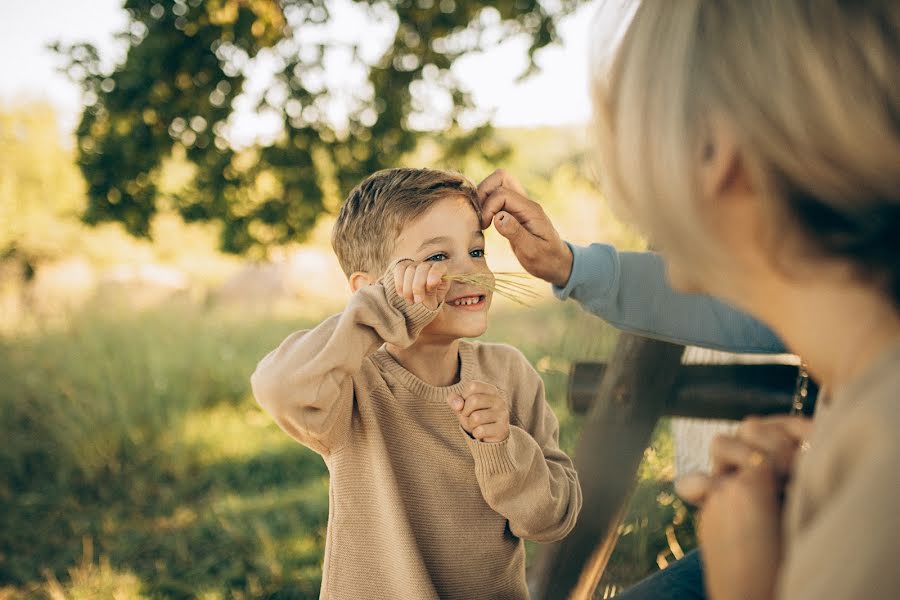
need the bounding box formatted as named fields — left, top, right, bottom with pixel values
left=529, top=334, right=684, bottom=600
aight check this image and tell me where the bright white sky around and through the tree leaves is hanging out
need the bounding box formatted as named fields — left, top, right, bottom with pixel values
left=0, top=0, right=593, bottom=145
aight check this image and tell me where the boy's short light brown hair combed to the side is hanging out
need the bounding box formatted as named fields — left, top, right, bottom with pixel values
left=331, top=168, right=481, bottom=277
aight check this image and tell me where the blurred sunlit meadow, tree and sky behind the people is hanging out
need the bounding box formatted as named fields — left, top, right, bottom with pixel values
left=0, top=0, right=694, bottom=599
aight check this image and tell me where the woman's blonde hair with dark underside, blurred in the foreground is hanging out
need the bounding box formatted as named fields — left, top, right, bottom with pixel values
left=592, top=0, right=900, bottom=307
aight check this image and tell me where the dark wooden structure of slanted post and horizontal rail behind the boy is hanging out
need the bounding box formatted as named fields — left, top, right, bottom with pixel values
left=529, top=333, right=817, bottom=600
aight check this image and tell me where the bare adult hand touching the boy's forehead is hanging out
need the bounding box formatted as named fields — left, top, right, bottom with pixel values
left=478, top=169, right=572, bottom=287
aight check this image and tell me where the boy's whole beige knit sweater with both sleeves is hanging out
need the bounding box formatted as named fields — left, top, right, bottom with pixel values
left=252, top=279, right=581, bottom=600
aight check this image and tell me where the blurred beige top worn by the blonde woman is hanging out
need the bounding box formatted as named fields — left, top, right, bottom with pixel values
left=776, top=344, right=900, bottom=600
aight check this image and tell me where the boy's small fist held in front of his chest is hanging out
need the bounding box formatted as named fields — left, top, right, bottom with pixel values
left=447, top=381, right=509, bottom=443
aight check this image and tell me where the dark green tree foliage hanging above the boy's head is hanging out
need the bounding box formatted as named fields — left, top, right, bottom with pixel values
left=56, top=0, right=583, bottom=252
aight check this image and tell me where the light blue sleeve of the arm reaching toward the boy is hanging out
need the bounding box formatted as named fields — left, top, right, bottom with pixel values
left=553, top=244, right=788, bottom=354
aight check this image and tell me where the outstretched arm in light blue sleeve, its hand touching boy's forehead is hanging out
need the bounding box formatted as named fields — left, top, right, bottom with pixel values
left=478, top=169, right=786, bottom=354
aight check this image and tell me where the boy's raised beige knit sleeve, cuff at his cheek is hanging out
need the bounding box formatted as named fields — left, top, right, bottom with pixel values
left=251, top=272, right=440, bottom=456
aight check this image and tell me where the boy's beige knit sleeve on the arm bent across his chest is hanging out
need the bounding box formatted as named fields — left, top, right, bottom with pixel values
left=466, top=353, right=581, bottom=542
